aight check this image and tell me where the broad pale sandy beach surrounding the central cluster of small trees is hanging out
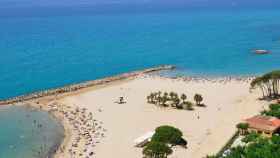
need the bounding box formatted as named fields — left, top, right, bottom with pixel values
left=31, top=75, right=266, bottom=158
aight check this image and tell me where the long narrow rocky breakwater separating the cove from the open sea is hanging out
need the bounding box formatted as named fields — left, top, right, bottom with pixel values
left=0, top=65, right=176, bottom=105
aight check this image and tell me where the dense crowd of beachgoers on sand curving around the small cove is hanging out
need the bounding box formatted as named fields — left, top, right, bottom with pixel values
left=49, top=103, right=106, bottom=158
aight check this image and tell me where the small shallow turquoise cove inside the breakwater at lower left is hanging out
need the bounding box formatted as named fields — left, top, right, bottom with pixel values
left=0, top=106, right=64, bottom=158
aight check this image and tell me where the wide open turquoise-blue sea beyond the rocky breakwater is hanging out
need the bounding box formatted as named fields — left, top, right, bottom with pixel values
left=0, top=9, right=280, bottom=99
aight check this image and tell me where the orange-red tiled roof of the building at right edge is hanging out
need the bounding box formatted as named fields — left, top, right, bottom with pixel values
left=246, top=115, right=280, bottom=131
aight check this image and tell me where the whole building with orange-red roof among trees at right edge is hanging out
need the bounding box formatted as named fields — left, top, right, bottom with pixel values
left=245, top=115, right=280, bottom=137
